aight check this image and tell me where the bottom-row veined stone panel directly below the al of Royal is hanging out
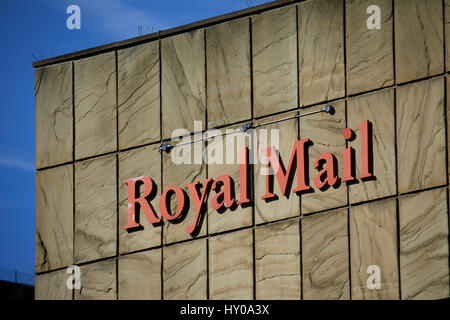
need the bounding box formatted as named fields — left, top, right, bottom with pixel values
left=209, top=229, right=253, bottom=300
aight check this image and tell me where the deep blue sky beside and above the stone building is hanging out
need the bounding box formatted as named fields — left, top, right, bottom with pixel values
left=0, top=0, right=268, bottom=273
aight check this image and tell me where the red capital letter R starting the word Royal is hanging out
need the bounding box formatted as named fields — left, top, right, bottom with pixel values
left=123, top=177, right=161, bottom=230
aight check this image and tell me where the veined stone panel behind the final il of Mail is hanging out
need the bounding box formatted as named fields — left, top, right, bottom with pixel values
left=347, top=89, right=396, bottom=203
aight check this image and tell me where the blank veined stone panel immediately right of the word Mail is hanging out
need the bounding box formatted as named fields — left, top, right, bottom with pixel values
left=397, top=78, right=447, bottom=193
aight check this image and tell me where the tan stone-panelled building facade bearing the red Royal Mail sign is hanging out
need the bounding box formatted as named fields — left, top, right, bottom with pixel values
left=34, top=0, right=450, bottom=300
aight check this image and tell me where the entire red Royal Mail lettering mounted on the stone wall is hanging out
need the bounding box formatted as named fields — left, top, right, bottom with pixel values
left=123, top=120, right=374, bottom=235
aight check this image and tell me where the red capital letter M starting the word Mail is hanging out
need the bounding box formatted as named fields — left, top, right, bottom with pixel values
left=261, top=139, right=311, bottom=199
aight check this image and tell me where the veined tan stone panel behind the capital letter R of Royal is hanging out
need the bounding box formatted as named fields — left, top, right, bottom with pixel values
left=118, top=145, right=162, bottom=254
